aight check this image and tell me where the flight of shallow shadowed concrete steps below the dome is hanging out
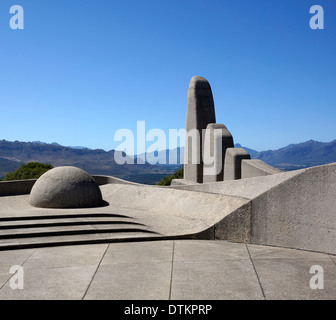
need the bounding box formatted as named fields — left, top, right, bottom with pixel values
left=0, top=212, right=161, bottom=250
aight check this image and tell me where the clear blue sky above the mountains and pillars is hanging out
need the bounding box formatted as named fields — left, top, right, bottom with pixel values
left=0, top=0, right=336, bottom=151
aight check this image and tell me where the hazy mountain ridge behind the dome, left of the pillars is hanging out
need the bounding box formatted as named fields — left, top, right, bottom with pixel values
left=0, top=140, right=180, bottom=184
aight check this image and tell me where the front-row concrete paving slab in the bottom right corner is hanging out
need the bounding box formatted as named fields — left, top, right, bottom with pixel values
left=253, top=253, right=336, bottom=300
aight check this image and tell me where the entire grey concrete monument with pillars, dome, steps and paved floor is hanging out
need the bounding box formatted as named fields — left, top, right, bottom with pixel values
left=0, top=77, right=336, bottom=300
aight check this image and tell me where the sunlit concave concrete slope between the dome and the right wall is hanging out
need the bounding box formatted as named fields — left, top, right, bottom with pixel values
left=101, top=185, right=249, bottom=239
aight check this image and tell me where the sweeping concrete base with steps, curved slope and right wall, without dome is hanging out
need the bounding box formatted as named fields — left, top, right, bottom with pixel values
left=0, top=164, right=336, bottom=254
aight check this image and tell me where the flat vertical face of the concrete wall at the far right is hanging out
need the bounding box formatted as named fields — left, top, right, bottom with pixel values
left=251, top=164, right=336, bottom=254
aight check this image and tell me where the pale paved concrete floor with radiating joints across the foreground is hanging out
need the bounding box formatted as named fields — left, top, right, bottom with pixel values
left=0, top=240, right=336, bottom=300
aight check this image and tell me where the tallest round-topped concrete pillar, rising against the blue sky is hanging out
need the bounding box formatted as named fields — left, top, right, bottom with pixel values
left=184, top=76, right=216, bottom=183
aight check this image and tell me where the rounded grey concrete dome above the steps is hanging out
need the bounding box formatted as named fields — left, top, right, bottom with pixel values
left=29, top=167, right=103, bottom=208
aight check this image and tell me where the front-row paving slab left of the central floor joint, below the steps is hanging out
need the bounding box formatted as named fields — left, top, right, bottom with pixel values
left=84, top=262, right=172, bottom=300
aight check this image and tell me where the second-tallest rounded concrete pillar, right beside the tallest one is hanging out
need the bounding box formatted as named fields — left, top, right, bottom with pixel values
left=203, top=123, right=234, bottom=183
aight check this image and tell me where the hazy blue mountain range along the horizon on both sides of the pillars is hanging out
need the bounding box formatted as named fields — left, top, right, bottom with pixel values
left=0, top=140, right=336, bottom=184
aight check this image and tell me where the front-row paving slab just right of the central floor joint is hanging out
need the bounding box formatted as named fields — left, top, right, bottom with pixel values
left=171, top=258, right=264, bottom=300
